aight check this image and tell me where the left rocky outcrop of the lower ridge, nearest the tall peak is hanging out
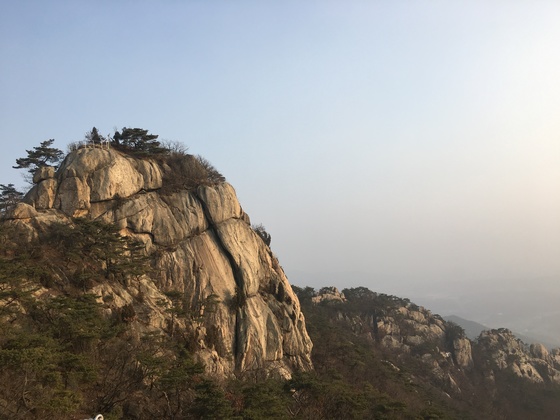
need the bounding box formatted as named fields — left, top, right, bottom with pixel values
left=311, top=287, right=473, bottom=394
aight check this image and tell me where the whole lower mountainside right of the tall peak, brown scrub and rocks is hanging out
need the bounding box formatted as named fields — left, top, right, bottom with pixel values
left=294, top=287, right=560, bottom=419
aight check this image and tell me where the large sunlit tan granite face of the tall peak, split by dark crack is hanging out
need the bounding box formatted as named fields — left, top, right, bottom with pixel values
left=11, top=148, right=312, bottom=377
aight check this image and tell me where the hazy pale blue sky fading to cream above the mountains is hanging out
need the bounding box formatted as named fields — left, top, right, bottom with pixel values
left=0, top=0, right=560, bottom=297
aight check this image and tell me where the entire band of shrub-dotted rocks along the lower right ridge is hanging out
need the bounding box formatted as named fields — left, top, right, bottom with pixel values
left=311, top=287, right=560, bottom=395
